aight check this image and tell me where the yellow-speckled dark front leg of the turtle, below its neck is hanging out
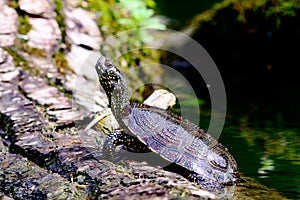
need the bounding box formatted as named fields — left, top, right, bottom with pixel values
left=103, top=130, right=151, bottom=160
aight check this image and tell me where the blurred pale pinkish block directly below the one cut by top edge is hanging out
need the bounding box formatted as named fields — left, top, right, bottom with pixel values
left=27, top=18, right=62, bottom=53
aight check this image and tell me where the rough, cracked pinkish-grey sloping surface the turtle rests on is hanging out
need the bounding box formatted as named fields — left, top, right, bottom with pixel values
left=0, top=0, right=288, bottom=199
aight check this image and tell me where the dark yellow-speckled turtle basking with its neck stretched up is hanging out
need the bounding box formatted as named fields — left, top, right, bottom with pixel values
left=95, top=56, right=240, bottom=190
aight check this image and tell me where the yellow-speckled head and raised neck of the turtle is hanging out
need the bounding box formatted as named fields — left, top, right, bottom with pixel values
left=96, top=56, right=129, bottom=115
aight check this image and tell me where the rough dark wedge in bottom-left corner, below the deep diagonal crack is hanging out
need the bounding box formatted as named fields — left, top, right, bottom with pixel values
left=0, top=153, right=87, bottom=199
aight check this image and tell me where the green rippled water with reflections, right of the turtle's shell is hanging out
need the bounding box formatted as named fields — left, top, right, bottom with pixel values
left=220, top=117, right=300, bottom=199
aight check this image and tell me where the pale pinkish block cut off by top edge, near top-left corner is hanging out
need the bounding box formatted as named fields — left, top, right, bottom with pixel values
left=19, top=0, right=55, bottom=18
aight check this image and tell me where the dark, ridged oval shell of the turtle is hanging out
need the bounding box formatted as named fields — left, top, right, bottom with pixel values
left=119, top=103, right=238, bottom=183
